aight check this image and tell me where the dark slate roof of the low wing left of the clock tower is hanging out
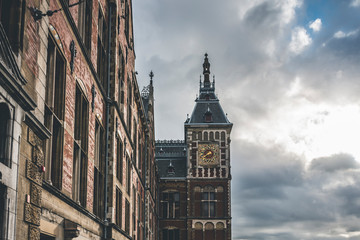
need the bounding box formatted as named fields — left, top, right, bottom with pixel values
left=155, top=140, right=187, bottom=179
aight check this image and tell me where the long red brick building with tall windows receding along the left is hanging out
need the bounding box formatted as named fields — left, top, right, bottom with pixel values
left=0, top=0, right=158, bottom=240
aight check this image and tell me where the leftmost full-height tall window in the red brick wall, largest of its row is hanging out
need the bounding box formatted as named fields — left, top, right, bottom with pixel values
left=44, top=31, right=67, bottom=189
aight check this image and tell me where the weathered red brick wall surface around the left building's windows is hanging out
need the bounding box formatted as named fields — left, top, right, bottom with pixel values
left=12, top=0, right=157, bottom=240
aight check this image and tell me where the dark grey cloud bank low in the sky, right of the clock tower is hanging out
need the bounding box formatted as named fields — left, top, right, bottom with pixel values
left=233, top=140, right=360, bottom=237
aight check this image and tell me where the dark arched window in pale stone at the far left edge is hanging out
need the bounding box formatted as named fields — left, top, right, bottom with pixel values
left=0, top=103, right=12, bottom=166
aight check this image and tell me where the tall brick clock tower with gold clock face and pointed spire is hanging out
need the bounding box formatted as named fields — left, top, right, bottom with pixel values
left=185, top=54, right=232, bottom=240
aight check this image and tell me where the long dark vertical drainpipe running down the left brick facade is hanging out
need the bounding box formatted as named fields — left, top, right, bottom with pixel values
left=104, top=3, right=113, bottom=239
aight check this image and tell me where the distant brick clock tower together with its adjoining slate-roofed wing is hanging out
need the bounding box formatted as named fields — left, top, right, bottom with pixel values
left=156, top=54, right=232, bottom=240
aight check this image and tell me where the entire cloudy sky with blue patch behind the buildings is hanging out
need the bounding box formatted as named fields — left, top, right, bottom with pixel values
left=133, top=0, right=360, bottom=240
